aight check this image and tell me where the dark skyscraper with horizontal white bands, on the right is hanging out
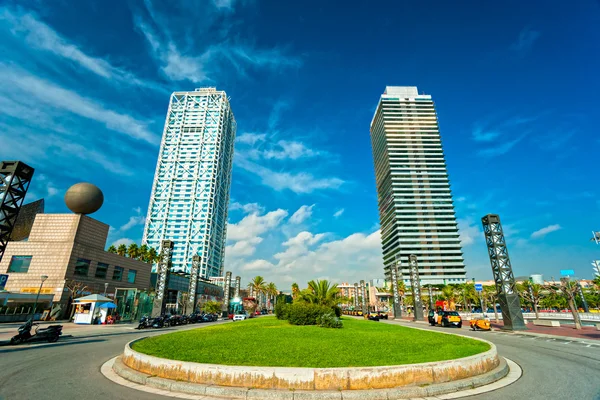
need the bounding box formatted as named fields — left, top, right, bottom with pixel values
left=371, top=86, right=466, bottom=284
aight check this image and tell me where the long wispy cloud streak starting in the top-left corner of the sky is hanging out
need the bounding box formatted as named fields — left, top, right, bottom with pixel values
left=0, top=7, right=164, bottom=90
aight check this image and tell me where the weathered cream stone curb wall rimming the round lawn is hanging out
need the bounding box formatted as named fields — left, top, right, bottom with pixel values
left=122, top=339, right=500, bottom=395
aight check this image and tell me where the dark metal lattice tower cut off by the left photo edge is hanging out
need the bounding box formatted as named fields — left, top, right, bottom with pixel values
left=0, top=161, right=34, bottom=260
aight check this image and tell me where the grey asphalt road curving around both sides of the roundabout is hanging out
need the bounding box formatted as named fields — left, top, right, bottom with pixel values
left=0, top=322, right=600, bottom=400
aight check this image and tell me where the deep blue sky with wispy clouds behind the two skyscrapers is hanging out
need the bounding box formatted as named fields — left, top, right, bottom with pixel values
left=0, top=0, right=600, bottom=288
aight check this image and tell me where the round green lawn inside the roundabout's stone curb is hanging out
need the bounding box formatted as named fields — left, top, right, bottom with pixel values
left=133, top=317, right=489, bottom=368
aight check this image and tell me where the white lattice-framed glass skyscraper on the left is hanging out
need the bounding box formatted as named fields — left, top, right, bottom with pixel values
left=143, top=88, right=236, bottom=278
